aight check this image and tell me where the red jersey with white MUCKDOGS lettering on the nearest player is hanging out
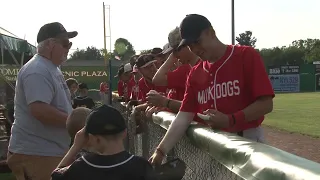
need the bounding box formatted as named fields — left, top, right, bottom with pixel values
left=180, top=46, right=274, bottom=132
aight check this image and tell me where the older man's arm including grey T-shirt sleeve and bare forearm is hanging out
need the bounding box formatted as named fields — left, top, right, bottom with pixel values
left=22, top=73, right=71, bottom=127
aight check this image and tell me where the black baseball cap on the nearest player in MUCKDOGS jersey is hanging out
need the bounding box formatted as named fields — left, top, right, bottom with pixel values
left=178, top=14, right=212, bottom=48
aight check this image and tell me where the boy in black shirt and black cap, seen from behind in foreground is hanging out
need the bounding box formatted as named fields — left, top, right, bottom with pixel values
left=51, top=105, right=156, bottom=180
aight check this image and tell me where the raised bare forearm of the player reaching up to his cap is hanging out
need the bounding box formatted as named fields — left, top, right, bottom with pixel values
left=152, top=56, right=174, bottom=86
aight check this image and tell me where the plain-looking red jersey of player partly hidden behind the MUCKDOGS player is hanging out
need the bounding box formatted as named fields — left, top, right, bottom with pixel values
left=167, top=60, right=200, bottom=101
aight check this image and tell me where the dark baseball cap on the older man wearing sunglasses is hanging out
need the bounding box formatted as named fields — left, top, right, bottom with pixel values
left=37, top=22, right=78, bottom=43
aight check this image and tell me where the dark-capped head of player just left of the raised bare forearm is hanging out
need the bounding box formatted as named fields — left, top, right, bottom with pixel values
left=136, top=54, right=158, bottom=80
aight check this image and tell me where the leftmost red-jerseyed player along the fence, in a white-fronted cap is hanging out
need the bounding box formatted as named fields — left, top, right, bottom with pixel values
left=117, top=63, right=133, bottom=102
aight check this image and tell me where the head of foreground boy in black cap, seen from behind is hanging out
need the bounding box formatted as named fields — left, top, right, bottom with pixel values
left=85, top=105, right=127, bottom=153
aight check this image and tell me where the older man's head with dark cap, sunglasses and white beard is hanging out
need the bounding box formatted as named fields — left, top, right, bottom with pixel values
left=37, top=22, right=78, bottom=65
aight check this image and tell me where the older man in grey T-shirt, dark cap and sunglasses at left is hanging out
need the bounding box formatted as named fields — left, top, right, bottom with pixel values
left=7, top=22, right=78, bottom=180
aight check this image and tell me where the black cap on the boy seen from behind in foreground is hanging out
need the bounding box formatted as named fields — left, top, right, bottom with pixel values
left=85, top=105, right=127, bottom=135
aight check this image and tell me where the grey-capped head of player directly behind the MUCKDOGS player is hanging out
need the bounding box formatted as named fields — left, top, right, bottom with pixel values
left=167, top=27, right=196, bottom=64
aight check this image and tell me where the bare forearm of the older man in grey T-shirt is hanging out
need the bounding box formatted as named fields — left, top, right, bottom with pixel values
left=29, top=102, right=68, bottom=127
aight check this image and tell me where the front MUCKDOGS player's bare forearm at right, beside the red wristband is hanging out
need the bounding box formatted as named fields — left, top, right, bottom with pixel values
left=243, top=96, right=273, bottom=121
